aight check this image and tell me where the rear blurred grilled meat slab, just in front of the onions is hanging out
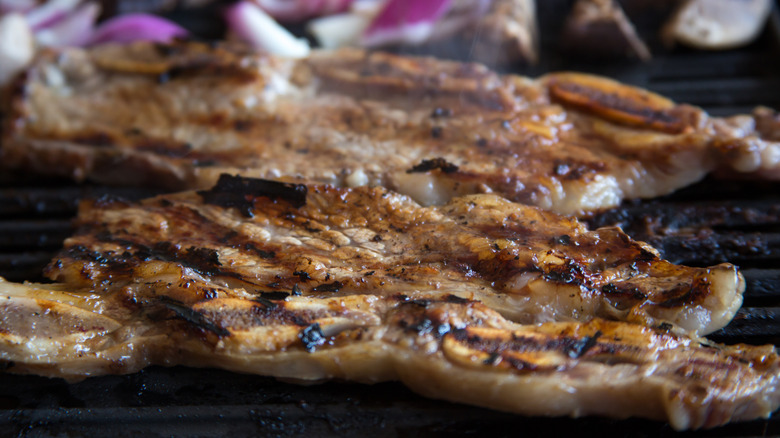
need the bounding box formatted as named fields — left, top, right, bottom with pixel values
left=0, top=43, right=780, bottom=214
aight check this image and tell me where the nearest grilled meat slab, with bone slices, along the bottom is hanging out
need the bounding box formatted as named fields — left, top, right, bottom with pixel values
left=0, top=278, right=780, bottom=429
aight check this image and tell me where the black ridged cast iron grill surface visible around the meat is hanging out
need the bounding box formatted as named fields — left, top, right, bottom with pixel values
left=0, top=0, right=780, bottom=437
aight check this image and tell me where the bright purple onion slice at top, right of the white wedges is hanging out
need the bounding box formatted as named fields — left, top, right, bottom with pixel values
left=361, top=0, right=452, bottom=47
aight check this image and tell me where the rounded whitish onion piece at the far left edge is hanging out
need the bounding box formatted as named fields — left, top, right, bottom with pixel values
left=0, top=12, right=35, bottom=85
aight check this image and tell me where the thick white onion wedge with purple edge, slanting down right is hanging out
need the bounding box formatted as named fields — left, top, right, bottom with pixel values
left=225, top=1, right=310, bottom=58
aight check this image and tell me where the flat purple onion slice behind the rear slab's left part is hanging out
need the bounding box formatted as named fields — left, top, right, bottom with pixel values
left=88, top=13, right=188, bottom=44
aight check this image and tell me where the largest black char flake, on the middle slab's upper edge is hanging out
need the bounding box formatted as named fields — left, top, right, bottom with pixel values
left=198, top=174, right=307, bottom=217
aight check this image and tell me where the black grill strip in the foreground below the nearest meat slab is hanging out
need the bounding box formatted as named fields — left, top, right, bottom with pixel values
left=0, top=367, right=780, bottom=438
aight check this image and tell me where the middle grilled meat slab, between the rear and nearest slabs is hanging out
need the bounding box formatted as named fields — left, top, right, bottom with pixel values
left=47, top=175, right=744, bottom=334
